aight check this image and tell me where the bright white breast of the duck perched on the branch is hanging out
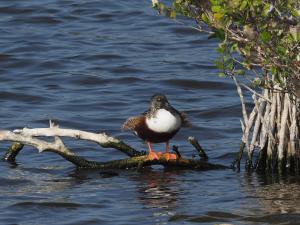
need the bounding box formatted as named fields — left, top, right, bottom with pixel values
left=146, top=109, right=181, bottom=133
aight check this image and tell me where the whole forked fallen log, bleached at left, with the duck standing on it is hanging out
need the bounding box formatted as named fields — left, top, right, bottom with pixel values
left=0, top=121, right=229, bottom=170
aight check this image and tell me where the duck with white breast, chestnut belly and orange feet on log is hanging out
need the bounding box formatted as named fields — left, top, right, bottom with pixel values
left=122, top=94, right=191, bottom=161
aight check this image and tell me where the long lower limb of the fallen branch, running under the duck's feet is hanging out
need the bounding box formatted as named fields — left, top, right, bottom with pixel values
left=0, top=126, right=229, bottom=170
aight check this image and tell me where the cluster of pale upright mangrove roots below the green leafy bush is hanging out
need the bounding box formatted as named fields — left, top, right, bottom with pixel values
left=233, top=76, right=300, bottom=174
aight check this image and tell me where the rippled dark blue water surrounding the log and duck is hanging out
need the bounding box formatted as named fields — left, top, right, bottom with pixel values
left=0, top=0, right=300, bottom=225
